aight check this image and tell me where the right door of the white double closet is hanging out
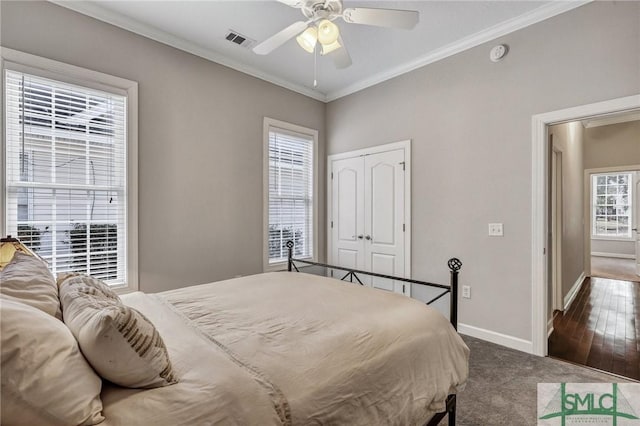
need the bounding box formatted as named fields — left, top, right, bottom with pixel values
left=364, top=149, right=405, bottom=293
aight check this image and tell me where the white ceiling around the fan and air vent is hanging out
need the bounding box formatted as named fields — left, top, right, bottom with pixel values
left=54, top=0, right=585, bottom=101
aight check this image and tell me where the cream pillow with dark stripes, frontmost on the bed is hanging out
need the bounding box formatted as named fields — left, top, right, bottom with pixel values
left=59, top=275, right=177, bottom=388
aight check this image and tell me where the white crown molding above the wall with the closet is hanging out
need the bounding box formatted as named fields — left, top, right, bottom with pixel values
left=326, top=0, right=593, bottom=102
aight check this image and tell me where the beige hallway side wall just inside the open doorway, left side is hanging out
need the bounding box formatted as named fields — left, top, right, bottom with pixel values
left=549, top=121, right=584, bottom=297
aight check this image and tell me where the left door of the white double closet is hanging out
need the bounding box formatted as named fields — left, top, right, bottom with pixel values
left=331, top=157, right=365, bottom=269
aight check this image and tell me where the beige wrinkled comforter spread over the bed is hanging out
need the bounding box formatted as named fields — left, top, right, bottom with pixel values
left=102, top=272, right=469, bottom=425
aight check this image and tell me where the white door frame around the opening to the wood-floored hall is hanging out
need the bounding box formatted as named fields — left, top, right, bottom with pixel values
left=531, top=94, right=640, bottom=356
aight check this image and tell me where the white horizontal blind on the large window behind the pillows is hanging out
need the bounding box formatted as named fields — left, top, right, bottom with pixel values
left=5, top=70, right=127, bottom=285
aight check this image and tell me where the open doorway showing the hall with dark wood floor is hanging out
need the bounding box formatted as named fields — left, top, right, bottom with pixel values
left=547, top=112, right=640, bottom=380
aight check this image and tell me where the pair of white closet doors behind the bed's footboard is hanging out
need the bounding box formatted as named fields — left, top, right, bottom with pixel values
left=331, top=149, right=408, bottom=293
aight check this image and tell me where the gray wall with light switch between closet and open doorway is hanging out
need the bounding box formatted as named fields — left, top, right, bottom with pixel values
left=327, top=2, right=640, bottom=340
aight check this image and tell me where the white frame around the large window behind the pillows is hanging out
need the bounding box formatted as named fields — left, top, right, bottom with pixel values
left=0, top=47, right=139, bottom=293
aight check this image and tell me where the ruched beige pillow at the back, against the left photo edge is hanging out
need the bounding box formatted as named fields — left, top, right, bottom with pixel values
left=0, top=251, right=62, bottom=320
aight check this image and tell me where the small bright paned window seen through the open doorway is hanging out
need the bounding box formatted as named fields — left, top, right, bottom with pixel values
left=591, top=173, right=632, bottom=238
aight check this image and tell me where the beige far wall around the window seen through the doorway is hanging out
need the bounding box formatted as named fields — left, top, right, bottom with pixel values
left=584, top=121, right=640, bottom=256
